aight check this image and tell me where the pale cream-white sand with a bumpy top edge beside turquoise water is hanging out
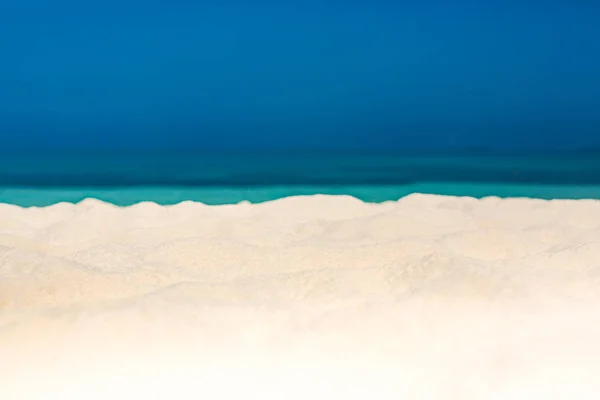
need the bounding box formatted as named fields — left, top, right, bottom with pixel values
left=0, top=195, right=600, bottom=400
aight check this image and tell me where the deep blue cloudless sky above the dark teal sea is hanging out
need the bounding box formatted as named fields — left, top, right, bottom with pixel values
left=0, top=0, right=600, bottom=149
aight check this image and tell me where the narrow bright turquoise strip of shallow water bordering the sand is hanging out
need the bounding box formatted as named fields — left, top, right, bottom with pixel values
left=0, top=184, right=600, bottom=207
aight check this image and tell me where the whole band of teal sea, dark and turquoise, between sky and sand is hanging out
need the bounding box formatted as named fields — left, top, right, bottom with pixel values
left=0, top=151, right=600, bottom=207
